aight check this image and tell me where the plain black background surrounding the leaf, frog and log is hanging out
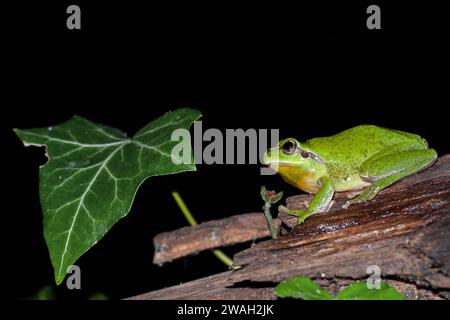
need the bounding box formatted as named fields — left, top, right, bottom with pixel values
left=0, top=1, right=450, bottom=299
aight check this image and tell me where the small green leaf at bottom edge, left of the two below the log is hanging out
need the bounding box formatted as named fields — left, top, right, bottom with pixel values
left=275, top=276, right=333, bottom=300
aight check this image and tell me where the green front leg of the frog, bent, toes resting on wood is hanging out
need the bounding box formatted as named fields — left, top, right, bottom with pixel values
left=279, top=176, right=334, bottom=223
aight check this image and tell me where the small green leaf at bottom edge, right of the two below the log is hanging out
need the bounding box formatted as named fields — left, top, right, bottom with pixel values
left=336, top=281, right=405, bottom=300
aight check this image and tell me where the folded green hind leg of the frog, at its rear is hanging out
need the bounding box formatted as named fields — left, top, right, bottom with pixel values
left=342, top=149, right=437, bottom=208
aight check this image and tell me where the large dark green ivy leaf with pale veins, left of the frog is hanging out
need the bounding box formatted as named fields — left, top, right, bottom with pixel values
left=14, top=109, right=201, bottom=284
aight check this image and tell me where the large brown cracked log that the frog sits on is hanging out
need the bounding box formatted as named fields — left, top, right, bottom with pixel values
left=128, top=155, right=450, bottom=299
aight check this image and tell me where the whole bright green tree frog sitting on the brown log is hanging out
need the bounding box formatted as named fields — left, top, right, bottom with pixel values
left=264, top=125, right=437, bottom=223
